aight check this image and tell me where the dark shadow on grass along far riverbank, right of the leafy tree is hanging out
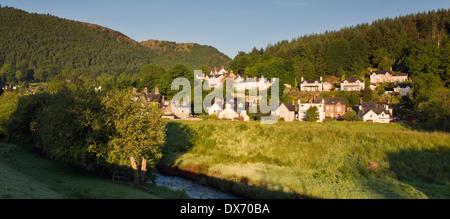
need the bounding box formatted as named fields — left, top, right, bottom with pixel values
left=157, top=122, right=305, bottom=199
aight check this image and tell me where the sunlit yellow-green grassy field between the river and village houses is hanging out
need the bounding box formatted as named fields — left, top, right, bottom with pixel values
left=162, top=121, right=450, bottom=199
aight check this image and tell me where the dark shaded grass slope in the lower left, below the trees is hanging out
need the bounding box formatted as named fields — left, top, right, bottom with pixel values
left=0, top=143, right=187, bottom=199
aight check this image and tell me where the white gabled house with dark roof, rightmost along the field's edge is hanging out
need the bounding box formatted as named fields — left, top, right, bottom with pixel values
left=358, top=101, right=393, bottom=123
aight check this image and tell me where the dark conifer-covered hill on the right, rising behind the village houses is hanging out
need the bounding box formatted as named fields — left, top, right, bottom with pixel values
left=230, top=9, right=450, bottom=84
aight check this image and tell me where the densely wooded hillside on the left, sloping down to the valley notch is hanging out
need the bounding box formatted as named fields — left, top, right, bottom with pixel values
left=0, top=7, right=230, bottom=81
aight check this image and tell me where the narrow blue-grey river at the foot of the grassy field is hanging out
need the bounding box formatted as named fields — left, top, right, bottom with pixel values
left=155, top=173, right=242, bottom=199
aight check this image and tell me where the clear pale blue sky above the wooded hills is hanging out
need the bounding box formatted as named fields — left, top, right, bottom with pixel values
left=0, top=0, right=450, bottom=58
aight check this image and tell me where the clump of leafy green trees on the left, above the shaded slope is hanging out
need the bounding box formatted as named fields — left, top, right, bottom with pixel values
left=0, top=86, right=166, bottom=184
